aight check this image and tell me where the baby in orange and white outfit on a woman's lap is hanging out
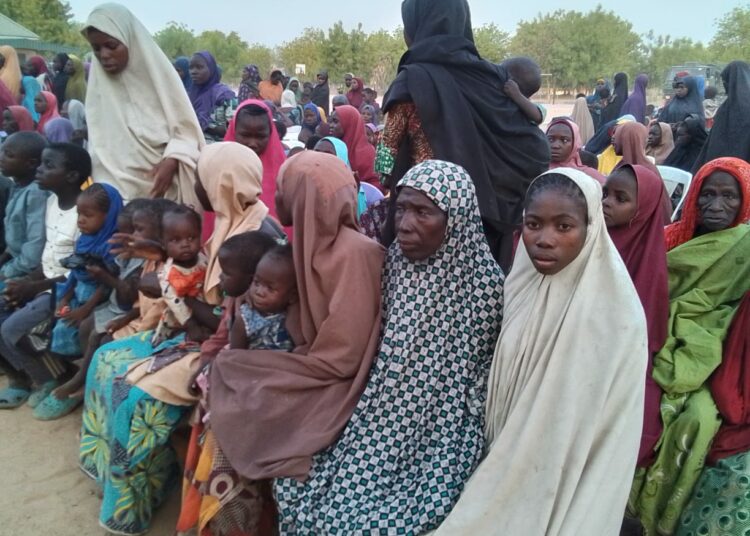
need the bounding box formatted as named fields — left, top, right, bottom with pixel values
left=151, top=205, right=207, bottom=347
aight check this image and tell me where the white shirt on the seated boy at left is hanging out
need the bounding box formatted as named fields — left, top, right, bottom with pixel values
left=42, top=194, right=80, bottom=279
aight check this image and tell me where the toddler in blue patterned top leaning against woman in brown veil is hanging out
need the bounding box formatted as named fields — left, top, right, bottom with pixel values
left=229, top=244, right=297, bottom=351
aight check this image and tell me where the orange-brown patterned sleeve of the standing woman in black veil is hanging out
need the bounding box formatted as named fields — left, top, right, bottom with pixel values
left=375, top=102, right=433, bottom=181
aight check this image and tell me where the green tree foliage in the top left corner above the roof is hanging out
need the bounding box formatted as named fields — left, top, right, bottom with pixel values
left=0, top=0, right=88, bottom=48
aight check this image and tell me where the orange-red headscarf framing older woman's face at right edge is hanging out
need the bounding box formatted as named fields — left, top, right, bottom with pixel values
left=664, top=157, right=750, bottom=250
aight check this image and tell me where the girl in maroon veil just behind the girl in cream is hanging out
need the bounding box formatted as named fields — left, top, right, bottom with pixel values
left=602, top=165, right=669, bottom=467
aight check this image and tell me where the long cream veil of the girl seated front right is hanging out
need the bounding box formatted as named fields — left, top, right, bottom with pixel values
left=437, top=168, right=648, bottom=536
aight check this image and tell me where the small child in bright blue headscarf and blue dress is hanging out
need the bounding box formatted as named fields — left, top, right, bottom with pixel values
left=50, top=183, right=122, bottom=358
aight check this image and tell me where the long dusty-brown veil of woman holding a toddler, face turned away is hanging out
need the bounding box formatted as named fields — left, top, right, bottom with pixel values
left=209, top=151, right=384, bottom=480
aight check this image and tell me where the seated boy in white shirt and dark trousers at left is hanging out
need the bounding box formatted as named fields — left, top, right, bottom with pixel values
left=0, top=140, right=86, bottom=408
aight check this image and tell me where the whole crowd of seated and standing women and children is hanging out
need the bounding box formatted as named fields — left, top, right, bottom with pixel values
left=0, top=0, right=750, bottom=536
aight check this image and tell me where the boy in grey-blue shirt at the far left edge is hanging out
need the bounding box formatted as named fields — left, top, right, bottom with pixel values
left=0, top=132, right=49, bottom=284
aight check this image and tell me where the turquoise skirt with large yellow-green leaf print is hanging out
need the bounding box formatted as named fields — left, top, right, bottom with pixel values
left=79, top=331, right=189, bottom=534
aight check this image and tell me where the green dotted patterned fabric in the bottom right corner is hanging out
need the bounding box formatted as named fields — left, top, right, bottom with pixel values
left=676, top=452, right=750, bottom=536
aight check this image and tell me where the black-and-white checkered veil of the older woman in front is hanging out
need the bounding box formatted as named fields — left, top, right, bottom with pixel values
left=274, top=160, right=504, bottom=534
